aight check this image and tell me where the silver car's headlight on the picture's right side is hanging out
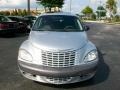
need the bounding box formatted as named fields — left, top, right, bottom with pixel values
left=85, top=50, right=98, bottom=62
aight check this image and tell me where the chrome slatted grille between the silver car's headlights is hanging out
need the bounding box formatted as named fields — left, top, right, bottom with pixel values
left=42, top=51, right=75, bottom=67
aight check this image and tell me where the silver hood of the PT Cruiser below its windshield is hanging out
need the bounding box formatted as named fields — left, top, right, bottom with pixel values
left=29, top=31, right=87, bottom=50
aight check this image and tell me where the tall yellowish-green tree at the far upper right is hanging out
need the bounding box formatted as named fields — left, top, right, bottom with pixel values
left=106, top=0, right=117, bottom=18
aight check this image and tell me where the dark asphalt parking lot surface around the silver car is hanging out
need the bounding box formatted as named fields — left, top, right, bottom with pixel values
left=0, top=23, right=120, bottom=90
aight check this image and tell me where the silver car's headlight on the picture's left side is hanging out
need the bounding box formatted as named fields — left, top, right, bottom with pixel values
left=19, top=49, right=33, bottom=62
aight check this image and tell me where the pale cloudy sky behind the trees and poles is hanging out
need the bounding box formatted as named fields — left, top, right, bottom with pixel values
left=0, top=0, right=120, bottom=13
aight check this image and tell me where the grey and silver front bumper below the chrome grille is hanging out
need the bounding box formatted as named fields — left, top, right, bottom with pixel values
left=18, top=61, right=98, bottom=84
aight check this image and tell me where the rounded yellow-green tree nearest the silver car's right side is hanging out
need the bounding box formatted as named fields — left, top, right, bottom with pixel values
left=82, top=6, right=93, bottom=19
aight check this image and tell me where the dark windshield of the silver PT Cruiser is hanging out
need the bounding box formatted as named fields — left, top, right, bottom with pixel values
left=33, top=15, right=83, bottom=32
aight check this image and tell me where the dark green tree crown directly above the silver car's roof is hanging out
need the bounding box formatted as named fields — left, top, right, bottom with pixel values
left=36, top=0, right=64, bottom=12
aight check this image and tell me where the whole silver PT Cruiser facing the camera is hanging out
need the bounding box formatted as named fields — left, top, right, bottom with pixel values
left=18, top=13, right=99, bottom=84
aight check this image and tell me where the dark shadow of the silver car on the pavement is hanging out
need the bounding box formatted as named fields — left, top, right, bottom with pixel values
left=38, top=51, right=110, bottom=89
